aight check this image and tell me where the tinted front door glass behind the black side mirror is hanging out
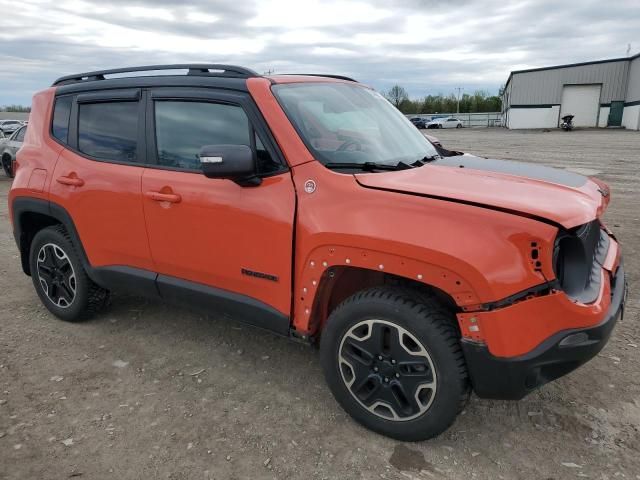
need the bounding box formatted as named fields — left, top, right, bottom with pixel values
left=155, top=101, right=253, bottom=170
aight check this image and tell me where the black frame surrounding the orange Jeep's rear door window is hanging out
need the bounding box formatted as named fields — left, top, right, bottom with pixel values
left=67, top=88, right=147, bottom=168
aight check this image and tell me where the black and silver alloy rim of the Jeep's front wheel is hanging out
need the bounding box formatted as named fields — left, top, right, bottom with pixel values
left=338, top=319, right=437, bottom=421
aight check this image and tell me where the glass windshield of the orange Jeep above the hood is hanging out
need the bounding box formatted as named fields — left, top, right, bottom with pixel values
left=272, top=83, right=438, bottom=166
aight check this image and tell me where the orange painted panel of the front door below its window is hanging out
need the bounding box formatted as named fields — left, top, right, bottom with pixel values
left=142, top=169, right=295, bottom=316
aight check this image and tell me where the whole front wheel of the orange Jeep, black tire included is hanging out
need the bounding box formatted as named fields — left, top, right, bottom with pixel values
left=320, top=287, right=470, bottom=441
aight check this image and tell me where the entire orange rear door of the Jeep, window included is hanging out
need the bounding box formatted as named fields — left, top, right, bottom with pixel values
left=50, top=89, right=153, bottom=270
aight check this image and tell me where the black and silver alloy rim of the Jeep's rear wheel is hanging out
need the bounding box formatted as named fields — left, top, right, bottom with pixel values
left=37, top=243, right=76, bottom=308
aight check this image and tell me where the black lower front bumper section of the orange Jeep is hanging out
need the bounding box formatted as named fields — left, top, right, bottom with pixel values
left=462, top=262, right=627, bottom=400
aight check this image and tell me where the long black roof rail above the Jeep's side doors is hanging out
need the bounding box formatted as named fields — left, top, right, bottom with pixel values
left=51, top=63, right=260, bottom=87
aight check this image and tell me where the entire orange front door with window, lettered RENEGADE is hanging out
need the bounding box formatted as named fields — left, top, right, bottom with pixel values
left=142, top=88, right=295, bottom=320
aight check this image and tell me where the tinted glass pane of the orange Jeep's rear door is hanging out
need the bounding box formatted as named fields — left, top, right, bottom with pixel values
left=78, top=102, right=139, bottom=162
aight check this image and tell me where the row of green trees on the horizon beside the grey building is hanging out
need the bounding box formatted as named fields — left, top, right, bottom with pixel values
left=385, top=85, right=502, bottom=114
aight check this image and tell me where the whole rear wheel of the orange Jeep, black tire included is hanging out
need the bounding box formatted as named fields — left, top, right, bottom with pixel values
left=29, top=225, right=110, bottom=322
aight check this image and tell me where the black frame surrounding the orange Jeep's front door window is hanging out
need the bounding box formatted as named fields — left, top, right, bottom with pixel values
left=145, top=87, right=289, bottom=178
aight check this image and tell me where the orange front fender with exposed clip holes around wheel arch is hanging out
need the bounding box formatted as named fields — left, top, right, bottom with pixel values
left=294, top=162, right=556, bottom=331
